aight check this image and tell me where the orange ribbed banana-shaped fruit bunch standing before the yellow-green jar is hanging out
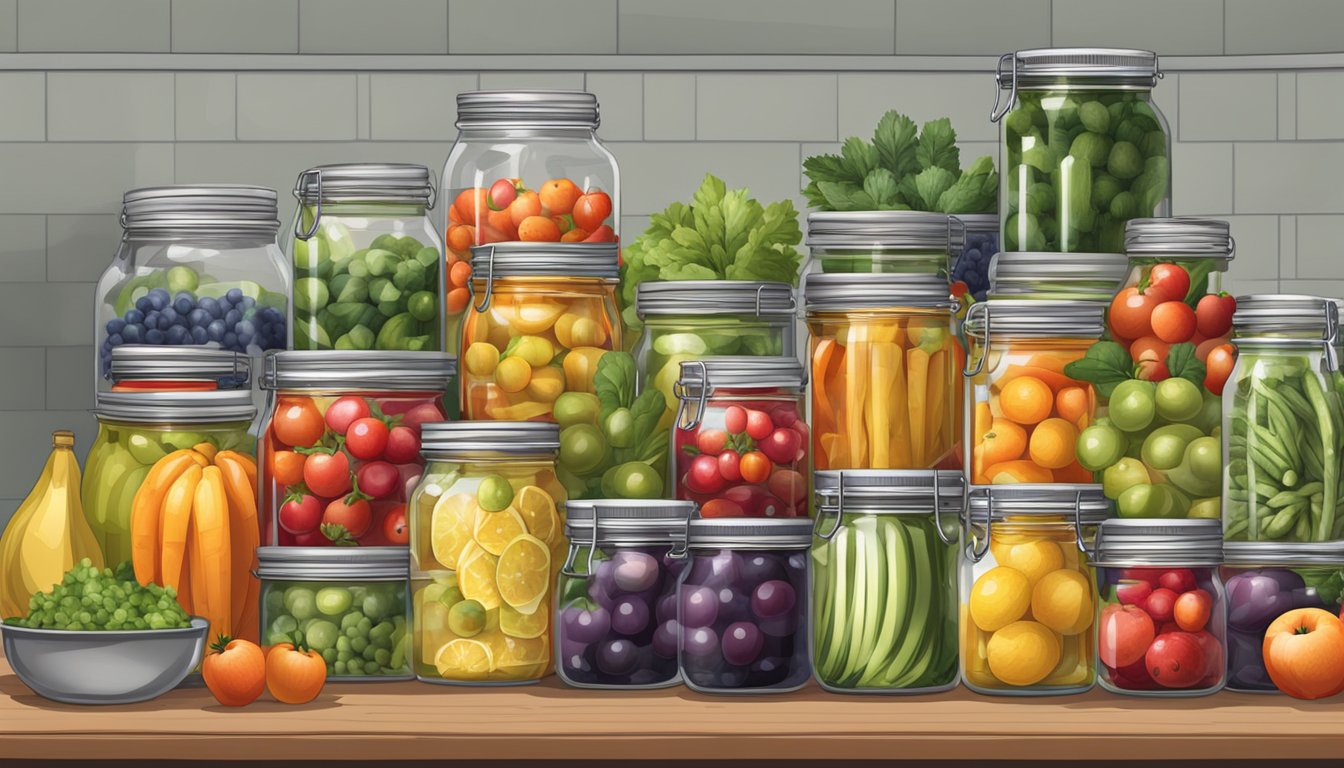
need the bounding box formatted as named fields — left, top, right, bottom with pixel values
left=130, top=444, right=259, bottom=639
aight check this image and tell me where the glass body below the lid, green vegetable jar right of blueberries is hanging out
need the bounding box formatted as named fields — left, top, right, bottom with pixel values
left=288, top=200, right=446, bottom=354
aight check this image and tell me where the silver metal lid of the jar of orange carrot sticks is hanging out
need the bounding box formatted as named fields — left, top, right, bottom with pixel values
left=802, top=272, right=957, bottom=312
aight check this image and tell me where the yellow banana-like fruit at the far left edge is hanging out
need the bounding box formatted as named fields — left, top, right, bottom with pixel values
left=0, top=429, right=103, bottom=623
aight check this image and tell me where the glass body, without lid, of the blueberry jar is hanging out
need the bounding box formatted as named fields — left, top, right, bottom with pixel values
left=94, top=230, right=289, bottom=391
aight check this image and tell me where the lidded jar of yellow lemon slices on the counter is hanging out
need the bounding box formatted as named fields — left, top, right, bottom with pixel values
left=410, top=421, right=567, bottom=685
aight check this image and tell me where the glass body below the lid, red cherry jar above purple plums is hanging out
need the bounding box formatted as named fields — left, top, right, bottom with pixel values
left=672, top=385, right=812, bottom=518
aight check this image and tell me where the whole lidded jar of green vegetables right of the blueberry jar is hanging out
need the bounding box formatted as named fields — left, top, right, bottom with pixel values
left=289, top=163, right=446, bottom=354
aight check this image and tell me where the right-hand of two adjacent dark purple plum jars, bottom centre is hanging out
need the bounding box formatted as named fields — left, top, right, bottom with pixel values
left=677, top=519, right=812, bottom=693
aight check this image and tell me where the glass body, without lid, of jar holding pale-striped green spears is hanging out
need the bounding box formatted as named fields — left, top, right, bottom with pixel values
left=812, top=510, right=958, bottom=693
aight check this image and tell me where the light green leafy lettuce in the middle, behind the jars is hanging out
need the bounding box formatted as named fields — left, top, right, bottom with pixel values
left=620, top=174, right=802, bottom=334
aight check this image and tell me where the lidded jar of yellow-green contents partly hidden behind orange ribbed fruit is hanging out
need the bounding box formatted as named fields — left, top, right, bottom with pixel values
left=79, top=390, right=257, bottom=568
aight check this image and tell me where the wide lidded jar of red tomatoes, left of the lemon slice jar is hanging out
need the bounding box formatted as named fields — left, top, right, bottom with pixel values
left=258, top=351, right=457, bottom=546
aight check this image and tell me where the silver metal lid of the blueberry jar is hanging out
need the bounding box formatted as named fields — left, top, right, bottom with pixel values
left=121, top=184, right=280, bottom=234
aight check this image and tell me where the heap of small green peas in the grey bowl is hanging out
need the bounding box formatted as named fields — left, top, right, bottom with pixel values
left=4, top=557, right=191, bottom=631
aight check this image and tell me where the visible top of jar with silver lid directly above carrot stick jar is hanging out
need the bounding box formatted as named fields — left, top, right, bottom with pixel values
left=802, top=211, right=965, bottom=278
